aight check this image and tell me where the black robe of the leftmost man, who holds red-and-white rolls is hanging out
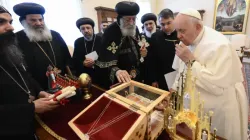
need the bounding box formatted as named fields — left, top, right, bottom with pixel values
left=0, top=61, right=41, bottom=140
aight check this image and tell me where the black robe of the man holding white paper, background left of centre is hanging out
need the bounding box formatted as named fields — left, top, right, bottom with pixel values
left=73, top=35, right=101, bottom=83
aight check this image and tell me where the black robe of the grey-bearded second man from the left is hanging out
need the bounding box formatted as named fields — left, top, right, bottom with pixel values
left=16, top=30, right=71, bottom=90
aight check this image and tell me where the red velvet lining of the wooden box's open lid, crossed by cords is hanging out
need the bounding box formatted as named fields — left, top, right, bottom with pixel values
left=74, top=97, right=140, bottom=140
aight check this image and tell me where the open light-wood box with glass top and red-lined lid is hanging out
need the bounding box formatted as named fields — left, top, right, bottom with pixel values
left=69, top=81, right=169, bottom=140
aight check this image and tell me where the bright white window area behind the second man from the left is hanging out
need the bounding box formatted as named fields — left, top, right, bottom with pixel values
left=0, top=0, right=82, bottom=46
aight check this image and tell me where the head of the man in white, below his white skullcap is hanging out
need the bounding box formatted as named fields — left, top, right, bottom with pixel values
left=174, top=10, right=203, bottom=45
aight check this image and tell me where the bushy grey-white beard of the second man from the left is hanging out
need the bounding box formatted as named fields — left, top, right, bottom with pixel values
left=21, top=20, right=52, bottom=42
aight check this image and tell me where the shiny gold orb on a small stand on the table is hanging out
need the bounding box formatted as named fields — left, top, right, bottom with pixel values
left=78, top=73, right=92, bottom=100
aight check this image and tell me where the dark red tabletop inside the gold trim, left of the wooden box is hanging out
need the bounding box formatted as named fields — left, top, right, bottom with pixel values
left=38, top=87, right=103, bottom=140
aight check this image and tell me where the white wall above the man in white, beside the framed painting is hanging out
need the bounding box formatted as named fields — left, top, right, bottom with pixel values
left=157, top=0, right=250, bottom=36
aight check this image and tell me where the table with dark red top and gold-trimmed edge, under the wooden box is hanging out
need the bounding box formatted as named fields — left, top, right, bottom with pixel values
left=36, top=85, right=225, bottom=140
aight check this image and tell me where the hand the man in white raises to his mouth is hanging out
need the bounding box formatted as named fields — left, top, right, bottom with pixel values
left=175, top=44, right=195, bottom=63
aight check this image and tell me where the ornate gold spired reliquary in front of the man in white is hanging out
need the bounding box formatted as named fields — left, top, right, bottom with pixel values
left=164, top=62, right=216, bottom=140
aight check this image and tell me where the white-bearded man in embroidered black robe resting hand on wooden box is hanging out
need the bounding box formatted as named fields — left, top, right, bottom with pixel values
left=97, top=1, right=145, bottom=87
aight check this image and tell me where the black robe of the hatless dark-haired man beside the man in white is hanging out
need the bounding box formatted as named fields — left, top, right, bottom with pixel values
left=149, top=31, right=179, bottom=90
